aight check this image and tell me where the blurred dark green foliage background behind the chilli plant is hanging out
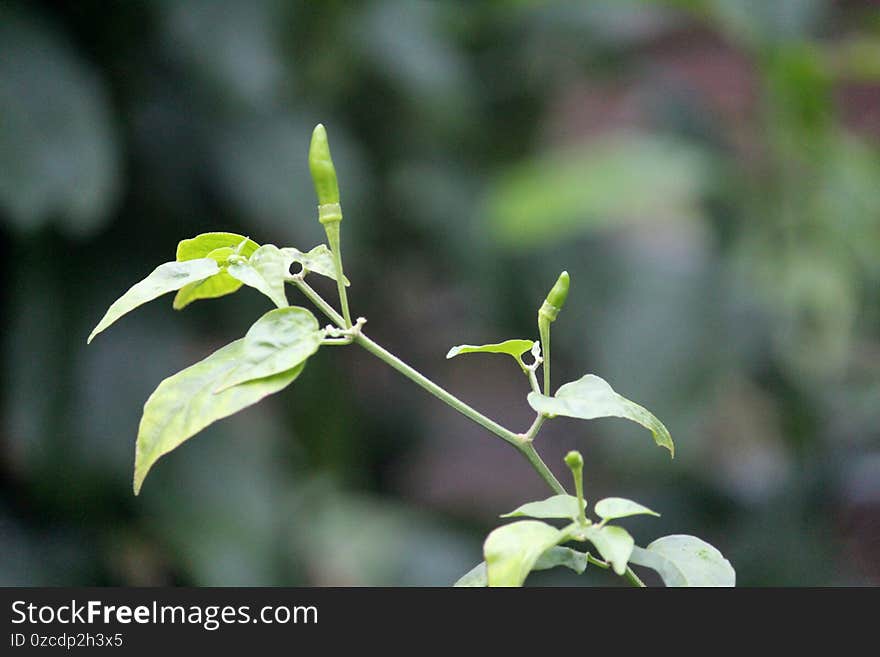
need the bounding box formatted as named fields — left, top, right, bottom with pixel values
left=0, top=0, right=880, bottom=586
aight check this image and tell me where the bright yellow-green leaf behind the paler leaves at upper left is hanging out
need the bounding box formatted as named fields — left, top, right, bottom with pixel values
left=174, top=233, right=259, bottom=310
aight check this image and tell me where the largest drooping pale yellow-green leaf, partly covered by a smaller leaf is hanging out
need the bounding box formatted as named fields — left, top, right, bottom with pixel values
left=134, top=339, right=305, bottom=495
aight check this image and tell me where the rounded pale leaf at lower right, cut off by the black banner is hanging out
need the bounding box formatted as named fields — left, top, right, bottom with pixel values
left=630, top=534, right=736, bottom=586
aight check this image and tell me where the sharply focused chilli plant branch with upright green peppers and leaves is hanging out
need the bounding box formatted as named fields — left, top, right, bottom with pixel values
left=88, top=125, right=735, bottom=586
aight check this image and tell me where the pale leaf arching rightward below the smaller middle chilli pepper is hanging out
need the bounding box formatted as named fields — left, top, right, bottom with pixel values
left=528, top=374, right=675, bottom=456
